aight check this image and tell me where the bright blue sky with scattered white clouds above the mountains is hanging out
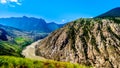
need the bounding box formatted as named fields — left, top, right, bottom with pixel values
left=0, top=0, right=120, bottom=23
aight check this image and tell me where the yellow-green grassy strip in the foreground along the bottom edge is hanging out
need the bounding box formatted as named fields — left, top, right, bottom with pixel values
left=0, top=56, right=92, bottom=68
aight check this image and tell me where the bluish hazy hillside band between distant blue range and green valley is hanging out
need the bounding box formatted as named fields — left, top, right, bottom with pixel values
left=0, top=24, right=48, bottom=41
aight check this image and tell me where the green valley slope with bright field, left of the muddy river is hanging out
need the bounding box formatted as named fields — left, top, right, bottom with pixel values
left=0, top=37, right=32, bottom=56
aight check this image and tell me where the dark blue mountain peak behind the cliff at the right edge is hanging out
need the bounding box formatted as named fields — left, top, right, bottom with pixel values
left=97, top=7, right=120, bottom=17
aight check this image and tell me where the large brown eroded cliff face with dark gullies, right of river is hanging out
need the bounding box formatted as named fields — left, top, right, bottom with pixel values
left=36, top=18, right=120, bottom=68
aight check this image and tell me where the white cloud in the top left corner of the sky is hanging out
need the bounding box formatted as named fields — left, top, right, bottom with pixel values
left=0, top=0, right=22, bottom=7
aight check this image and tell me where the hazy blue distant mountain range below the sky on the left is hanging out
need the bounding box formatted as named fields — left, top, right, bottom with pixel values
left=0, top=16, right=63, bottom=33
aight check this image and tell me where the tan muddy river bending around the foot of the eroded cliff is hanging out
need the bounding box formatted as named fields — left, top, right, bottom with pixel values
left=21, top=40, right=45, bottom=60
